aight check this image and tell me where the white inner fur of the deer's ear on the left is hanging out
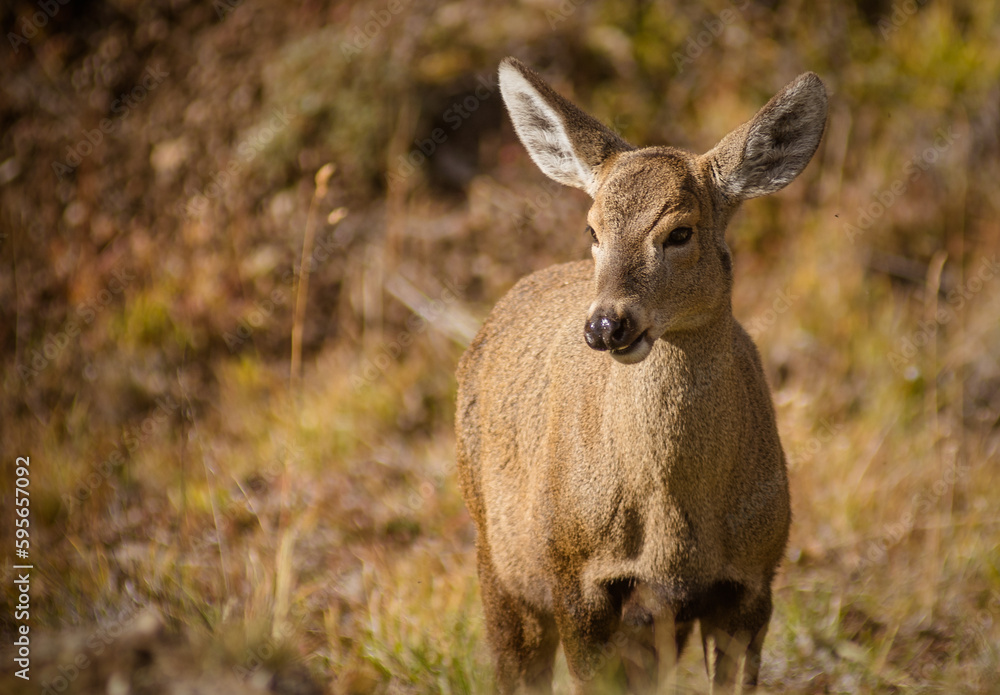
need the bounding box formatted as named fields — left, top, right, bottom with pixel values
left=500, top=65, right=597, bottom=197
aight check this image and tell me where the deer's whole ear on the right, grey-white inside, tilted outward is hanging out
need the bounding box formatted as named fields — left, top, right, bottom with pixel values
left=704, top=72, right=826, bottom=200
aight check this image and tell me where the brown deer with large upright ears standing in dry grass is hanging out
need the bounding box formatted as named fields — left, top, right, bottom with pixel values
left=456, top=58, right=827, bottom=693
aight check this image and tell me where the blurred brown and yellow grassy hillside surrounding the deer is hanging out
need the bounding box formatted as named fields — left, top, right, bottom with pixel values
left=0, top=0, right=1000, bottom=693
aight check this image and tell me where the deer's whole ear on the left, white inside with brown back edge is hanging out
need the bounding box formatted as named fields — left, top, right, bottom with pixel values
left=500, top=58, right=632, bottom=196
